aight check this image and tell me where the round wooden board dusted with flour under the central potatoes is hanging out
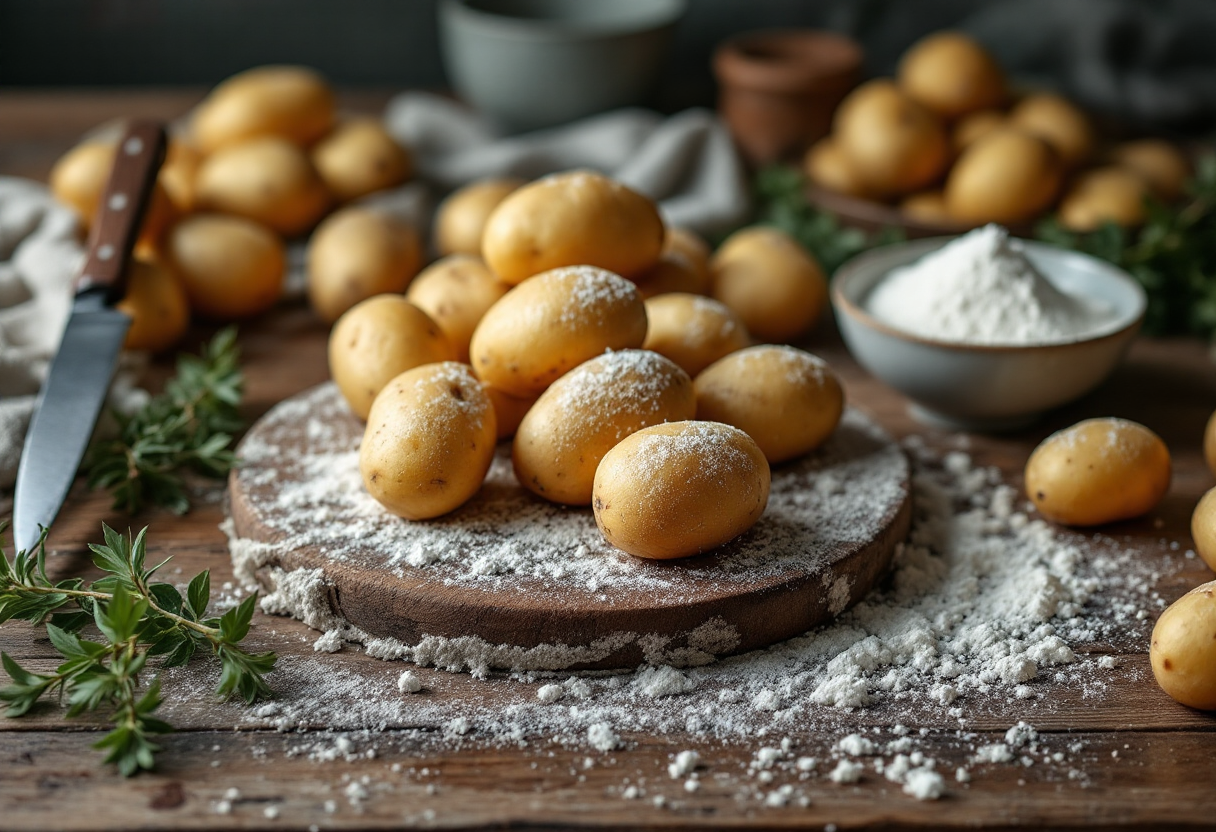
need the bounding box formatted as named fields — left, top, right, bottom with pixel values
left=230, top=384, right=911, bottom=669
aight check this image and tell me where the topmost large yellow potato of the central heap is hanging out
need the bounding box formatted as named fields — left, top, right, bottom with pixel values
left=482, top=170, right=664, bottom=283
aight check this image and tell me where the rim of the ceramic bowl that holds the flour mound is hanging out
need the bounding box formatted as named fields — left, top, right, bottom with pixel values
left=831, top=235, right=1148, bottom=353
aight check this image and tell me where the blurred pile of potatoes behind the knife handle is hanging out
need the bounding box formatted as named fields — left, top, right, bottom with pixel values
left=50, top=67, right=422, bottom=352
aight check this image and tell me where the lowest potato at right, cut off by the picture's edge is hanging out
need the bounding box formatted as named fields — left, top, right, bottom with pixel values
left=1149, top=581, right=1216, bottom=710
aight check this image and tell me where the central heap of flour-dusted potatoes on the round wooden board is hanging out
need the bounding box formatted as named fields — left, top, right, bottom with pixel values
left=328, top=170, right=844, bottom=558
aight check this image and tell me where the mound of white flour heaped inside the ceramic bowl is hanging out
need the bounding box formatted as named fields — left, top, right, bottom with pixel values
left=865, top=225, right=1115, bottom=345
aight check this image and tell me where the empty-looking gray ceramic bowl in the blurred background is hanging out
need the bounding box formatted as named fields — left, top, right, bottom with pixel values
left=439, top=0, right=685, bottom=130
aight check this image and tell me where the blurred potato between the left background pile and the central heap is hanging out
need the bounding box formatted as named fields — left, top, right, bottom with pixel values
left=308, top=207, right=422, bottom=324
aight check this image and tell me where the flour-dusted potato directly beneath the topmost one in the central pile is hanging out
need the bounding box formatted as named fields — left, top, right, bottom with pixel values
left=469, top=266, right=646, bottom=398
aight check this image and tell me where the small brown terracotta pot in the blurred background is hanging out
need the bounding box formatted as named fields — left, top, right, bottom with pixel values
left=714, top=29, right=862, bottom=164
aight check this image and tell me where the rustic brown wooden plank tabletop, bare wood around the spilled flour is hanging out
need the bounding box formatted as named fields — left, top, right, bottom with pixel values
left=0, top=92, right=1216, bottom=832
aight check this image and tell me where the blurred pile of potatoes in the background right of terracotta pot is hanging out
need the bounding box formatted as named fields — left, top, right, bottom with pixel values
left=804, top=32, right=1190, bottom=231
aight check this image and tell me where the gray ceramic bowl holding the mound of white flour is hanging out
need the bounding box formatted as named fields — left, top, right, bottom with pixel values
left=832, top=237, right=1147, bottom=431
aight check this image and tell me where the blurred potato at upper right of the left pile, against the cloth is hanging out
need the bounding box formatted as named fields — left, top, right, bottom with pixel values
left=313, top=118, right=413, bottom=202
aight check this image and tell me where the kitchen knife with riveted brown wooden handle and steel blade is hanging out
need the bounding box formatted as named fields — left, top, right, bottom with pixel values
left=13, top=122, right=165, bottom=551
